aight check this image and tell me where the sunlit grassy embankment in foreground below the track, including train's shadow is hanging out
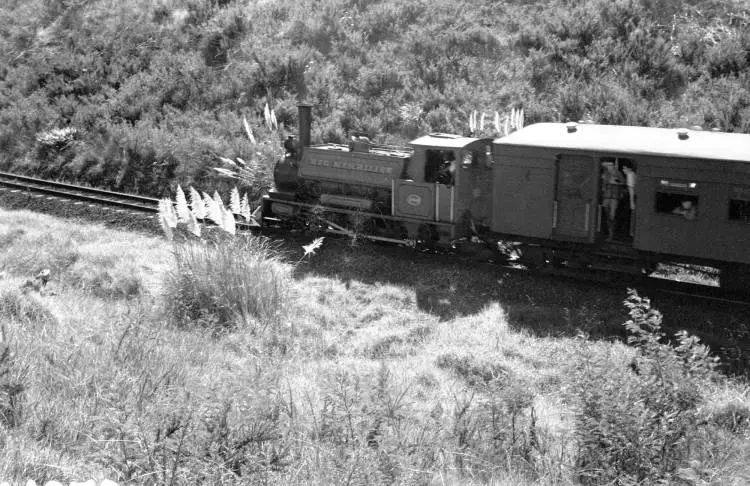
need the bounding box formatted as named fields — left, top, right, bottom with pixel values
left=0, top=210, right=750, bottom=484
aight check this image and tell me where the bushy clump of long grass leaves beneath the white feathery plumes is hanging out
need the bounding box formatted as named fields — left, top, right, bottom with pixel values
left=165, top=235, right=290, bottom=332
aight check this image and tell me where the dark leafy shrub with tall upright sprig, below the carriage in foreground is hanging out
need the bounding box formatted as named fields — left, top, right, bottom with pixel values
left=576, top=291, right=716, bottom=484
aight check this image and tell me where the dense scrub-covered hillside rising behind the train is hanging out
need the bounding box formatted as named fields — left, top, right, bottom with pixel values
left=0, top=0, right=750, bottom=195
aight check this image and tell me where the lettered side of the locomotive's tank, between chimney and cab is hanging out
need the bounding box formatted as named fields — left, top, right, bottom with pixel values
left=299, top=150, right=405, bottom=188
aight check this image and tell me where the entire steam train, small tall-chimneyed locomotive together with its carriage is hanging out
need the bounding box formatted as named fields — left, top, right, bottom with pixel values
left=261, top=105, right=750, bottom=289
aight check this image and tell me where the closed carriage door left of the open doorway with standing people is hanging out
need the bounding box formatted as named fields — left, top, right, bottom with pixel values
left=552, top=155, right=597, bottom=241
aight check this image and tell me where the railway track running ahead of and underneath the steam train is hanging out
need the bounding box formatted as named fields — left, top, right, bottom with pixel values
left=0, top=172, right=750, bottom=305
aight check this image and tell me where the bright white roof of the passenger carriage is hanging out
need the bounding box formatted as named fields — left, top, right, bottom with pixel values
left=495, top=123, right=750, bottom=162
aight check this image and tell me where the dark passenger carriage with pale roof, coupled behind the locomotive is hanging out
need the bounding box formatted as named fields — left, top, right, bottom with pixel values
left=490, top=123, right=750, bottom=286
